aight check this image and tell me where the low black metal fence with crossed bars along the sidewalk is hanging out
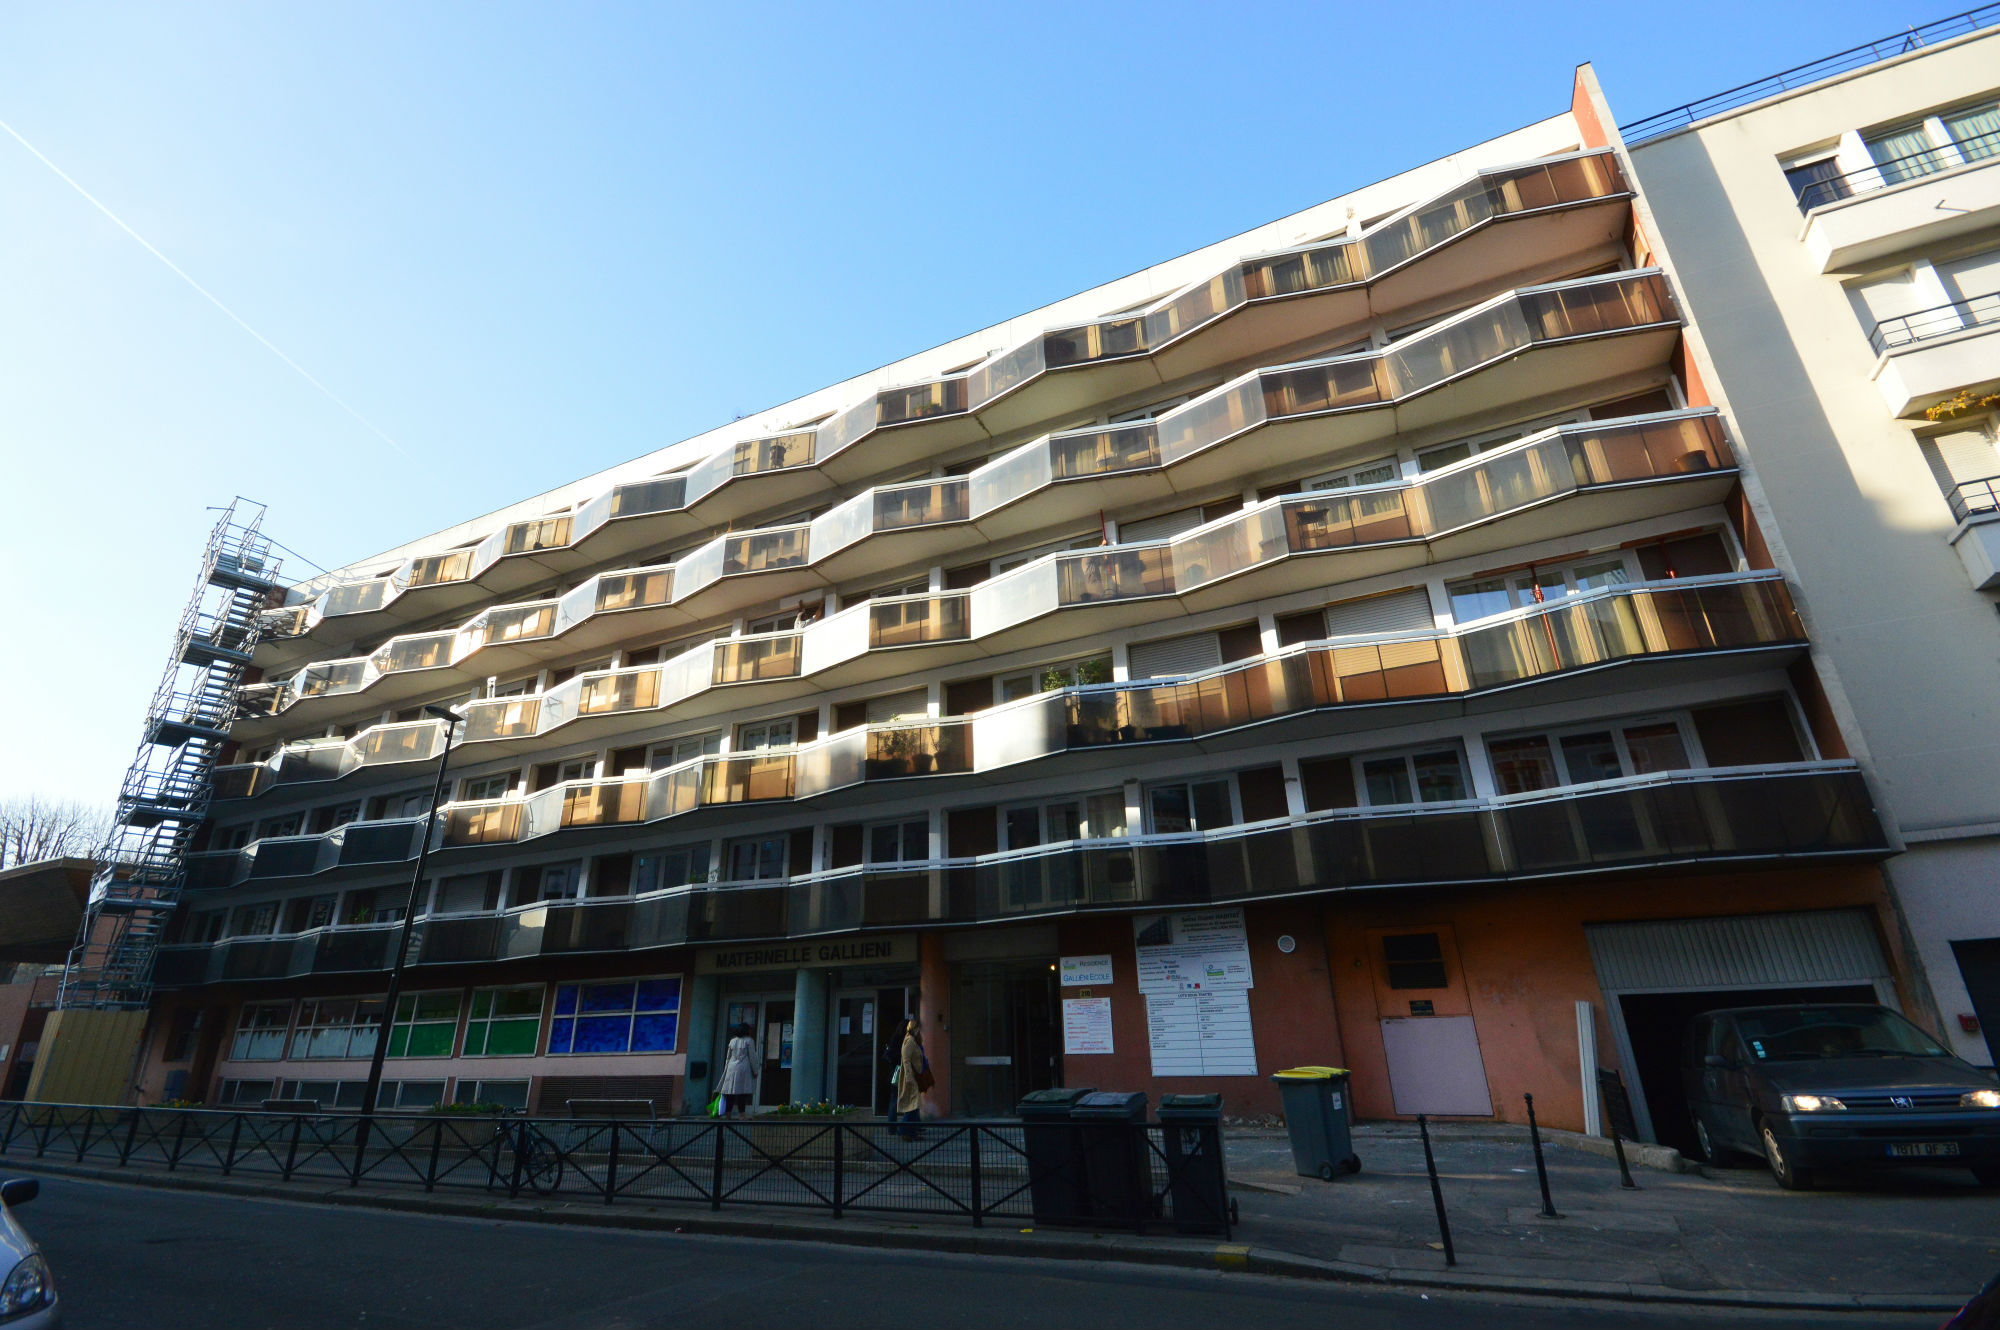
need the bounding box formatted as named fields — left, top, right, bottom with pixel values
left=0, top=1102, right=1232, bottom=1236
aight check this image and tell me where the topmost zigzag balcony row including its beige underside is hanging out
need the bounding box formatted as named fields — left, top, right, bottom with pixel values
left=270, top=152, right=1630, bottom=652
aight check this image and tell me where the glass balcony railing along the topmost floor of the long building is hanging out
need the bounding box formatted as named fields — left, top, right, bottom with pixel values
left=290, top=152, right=1628, bottom=626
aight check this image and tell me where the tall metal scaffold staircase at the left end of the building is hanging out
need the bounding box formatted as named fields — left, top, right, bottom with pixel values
left=58, top=498, right=278, bottom=1010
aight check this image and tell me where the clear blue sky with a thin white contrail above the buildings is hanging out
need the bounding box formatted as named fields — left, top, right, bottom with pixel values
left=0, top=0, right=1904, bottom=802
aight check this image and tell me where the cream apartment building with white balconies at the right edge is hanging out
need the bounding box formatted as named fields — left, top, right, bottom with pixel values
left=1628, top=6, right=2000, bottom=1066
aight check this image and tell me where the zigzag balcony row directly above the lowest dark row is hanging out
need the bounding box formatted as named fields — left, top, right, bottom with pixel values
left=188, top=572, right=1806, bottom=872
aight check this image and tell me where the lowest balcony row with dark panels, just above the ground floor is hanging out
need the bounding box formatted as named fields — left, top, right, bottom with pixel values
left=154, top=762, right=1888, bottom=988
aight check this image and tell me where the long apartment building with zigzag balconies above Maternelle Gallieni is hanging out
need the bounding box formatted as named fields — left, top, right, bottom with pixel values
left=78, top=70, right=1922, bottom=1140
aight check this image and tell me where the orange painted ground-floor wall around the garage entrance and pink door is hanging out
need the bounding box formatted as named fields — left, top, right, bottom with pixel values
left=1326, top=866, right=1916, bottom=1130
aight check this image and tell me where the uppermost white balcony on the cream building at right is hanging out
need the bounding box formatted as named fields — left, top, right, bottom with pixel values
left=1798, top=134, right=2000, bottom=272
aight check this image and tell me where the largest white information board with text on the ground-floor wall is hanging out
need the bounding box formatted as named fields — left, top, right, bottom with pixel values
left=1132, top=906, right=1256, bottom=1076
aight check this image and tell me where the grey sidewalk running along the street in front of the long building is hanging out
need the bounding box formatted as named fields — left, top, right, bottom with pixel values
left=0, top=1124, right=2000, bottom=1312
